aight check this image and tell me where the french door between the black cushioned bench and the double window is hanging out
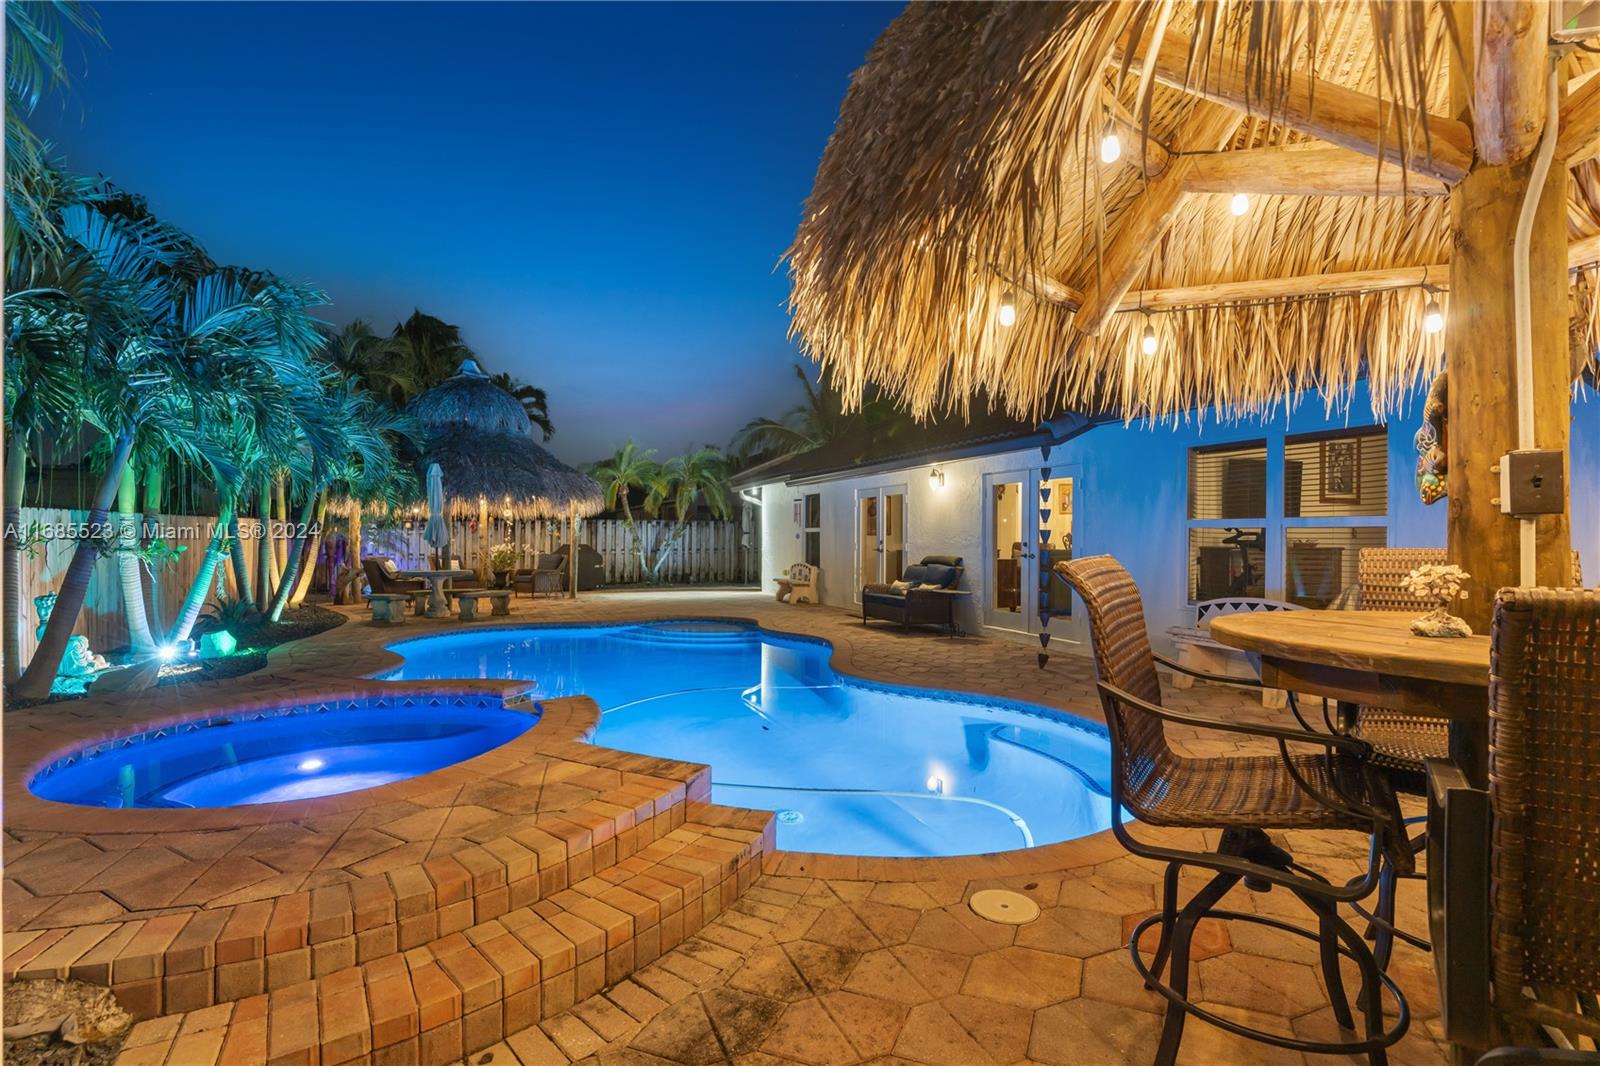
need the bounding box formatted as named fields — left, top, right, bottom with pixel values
left=982, top=464, right=1077, bottom=634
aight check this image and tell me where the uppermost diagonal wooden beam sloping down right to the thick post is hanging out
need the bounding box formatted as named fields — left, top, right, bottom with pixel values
left=1115, top=30, right=1472, bottom=184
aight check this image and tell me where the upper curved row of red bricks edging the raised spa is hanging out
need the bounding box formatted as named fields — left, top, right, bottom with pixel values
left=5, top=746, right=765, bottom=1018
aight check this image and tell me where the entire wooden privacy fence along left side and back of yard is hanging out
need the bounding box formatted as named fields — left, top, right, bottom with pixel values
left=10, top=507, right=760, bottom=661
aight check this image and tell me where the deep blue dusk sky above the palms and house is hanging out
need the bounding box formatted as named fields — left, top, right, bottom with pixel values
left=35, top=3, right=899, bottom=463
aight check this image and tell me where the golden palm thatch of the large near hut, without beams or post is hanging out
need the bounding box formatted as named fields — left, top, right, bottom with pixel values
left=789, top=0, right=1600, bottom=418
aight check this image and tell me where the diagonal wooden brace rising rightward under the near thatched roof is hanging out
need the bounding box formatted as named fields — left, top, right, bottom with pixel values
left=1074, top=104, right=1245, bottom=335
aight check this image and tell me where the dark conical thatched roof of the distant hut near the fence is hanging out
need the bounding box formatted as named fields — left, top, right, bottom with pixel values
left=406, top=360, right=603, bottom=519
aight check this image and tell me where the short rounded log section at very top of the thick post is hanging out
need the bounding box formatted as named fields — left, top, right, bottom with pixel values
left=1472, top=0, right=1550, bottom=166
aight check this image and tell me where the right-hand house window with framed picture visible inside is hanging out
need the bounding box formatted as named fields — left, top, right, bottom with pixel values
left=1283, top=427, right=1389, bottom=608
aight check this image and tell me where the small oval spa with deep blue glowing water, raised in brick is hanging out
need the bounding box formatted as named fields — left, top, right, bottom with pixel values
left=29, top=693, right=539, bottom=807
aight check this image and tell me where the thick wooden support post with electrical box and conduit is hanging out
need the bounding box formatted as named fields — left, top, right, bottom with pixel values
left=1445, top=8, right=1571, bottom=632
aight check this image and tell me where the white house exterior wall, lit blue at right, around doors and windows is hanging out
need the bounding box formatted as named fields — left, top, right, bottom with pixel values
left=760, top=384, right=1600, bottom=653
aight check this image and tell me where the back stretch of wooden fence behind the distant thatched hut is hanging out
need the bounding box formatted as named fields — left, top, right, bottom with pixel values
left=362, top=515, right=760, bottom=584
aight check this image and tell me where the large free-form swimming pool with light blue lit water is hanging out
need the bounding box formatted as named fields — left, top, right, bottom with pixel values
left=382, top=621, right=1110, bottom=856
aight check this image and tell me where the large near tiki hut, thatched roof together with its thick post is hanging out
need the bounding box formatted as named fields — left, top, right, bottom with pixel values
left=787, top=0, right=1600, bottom=623
